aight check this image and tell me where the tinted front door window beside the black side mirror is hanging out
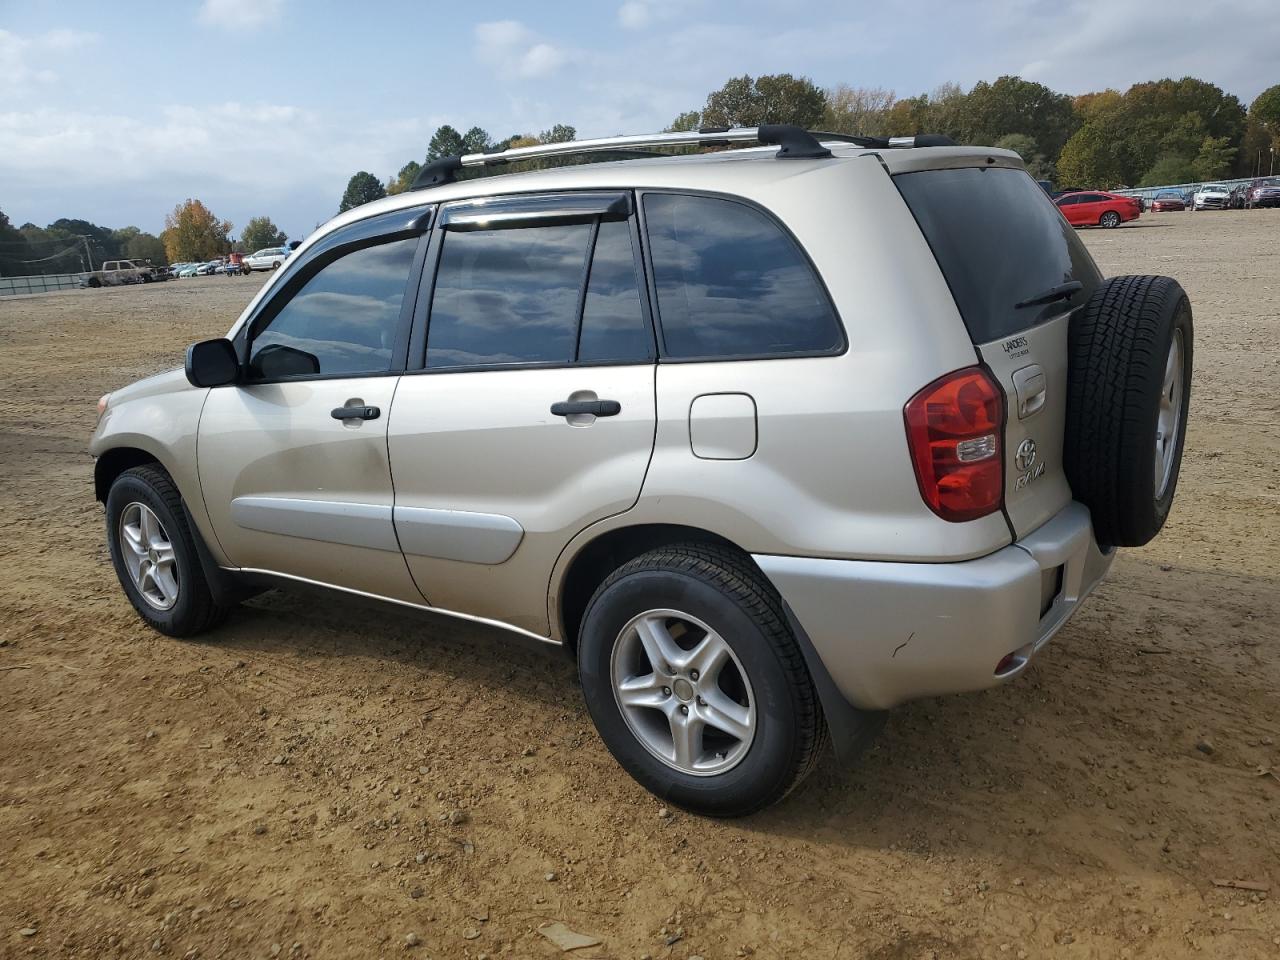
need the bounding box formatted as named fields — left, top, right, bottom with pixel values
left=250, top=237, right=417, bottom=379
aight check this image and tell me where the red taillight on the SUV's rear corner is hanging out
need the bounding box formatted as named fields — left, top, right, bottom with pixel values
left=904, top=367, right=1005, bottom=521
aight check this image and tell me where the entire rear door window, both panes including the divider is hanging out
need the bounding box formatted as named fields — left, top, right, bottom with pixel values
left=426, top=213, right=650, bottom=369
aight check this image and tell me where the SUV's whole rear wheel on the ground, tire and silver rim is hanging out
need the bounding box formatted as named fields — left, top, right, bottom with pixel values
left=577, top=544, right=827, bottom=817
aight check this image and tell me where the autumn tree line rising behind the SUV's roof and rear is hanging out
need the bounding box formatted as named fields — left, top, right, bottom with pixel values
left=338, top=73, right=1280, bottom=212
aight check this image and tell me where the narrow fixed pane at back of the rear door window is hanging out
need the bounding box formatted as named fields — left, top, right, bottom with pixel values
left=577, top=220, right=650, bottom=360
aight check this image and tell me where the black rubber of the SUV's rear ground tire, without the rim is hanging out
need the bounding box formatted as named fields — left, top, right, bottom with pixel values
left=577, top=543, right=827, bottom=817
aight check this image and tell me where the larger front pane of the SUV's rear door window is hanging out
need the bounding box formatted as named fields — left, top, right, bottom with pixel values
left=426, top=224, right=591, bottom=367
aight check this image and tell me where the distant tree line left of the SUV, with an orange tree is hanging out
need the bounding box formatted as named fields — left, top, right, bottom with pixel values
left=0, top=200, right=288, bottom=276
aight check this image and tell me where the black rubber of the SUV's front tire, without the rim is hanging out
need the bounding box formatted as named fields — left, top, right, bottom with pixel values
left=106, top=465, right=229, bottom=636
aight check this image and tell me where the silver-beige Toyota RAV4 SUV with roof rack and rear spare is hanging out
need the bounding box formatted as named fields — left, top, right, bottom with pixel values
left=91, top=127, right=1192, bottom=815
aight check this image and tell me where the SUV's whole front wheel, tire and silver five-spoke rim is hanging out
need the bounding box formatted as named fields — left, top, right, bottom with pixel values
left=106, top=465, right=227, bottom=636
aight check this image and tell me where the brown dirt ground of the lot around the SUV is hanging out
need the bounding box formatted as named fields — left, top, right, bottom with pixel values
left=0, top=210, right=1280, bottom=960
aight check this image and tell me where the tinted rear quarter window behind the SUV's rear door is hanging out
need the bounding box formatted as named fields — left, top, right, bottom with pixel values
left=644, top=187, right=839, bottom=357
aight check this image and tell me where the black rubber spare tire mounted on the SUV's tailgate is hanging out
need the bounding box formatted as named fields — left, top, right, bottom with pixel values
left=1064, top=276, right=1194, bottom=547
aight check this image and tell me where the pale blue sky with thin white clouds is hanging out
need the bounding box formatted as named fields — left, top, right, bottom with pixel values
left=0, top=0, right=1280, bottom=238
